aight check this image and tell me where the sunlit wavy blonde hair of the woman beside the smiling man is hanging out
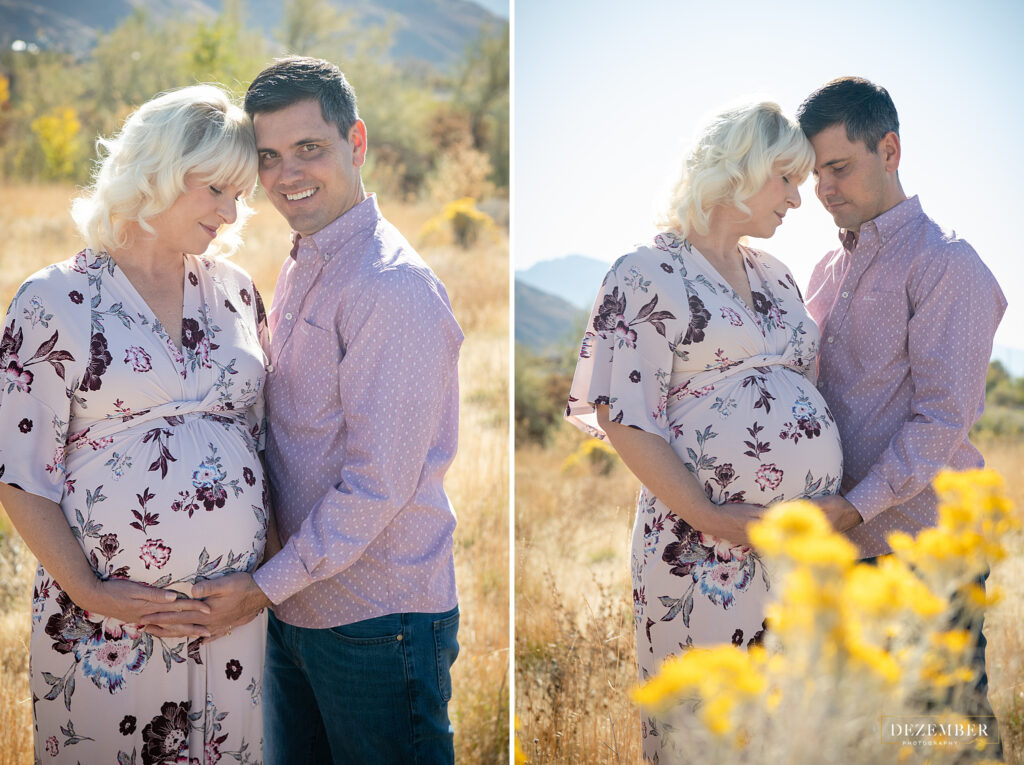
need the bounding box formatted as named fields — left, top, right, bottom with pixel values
left=72, top=85, right=258, bottom=256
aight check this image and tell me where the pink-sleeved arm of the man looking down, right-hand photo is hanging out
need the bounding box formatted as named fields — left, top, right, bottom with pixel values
left=846, top=242, right=1007, bottom=521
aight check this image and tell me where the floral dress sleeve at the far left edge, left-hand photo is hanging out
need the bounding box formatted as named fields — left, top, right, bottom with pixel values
left=0, top=274, right=78, bottom=503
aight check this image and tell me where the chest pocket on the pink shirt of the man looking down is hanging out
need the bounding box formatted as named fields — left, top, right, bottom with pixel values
left=849, top=289, right=910, bottom=369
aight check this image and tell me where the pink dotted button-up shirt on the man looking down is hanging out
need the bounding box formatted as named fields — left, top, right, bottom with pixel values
left=807, top=197, right=1007, bottom=557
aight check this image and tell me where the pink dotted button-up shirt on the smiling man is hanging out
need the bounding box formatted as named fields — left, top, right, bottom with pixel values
left=255, top=196, right=463, bottom=628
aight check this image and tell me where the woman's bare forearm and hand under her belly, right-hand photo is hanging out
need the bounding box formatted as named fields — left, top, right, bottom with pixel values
left=597, top=405, right=760, bottom=545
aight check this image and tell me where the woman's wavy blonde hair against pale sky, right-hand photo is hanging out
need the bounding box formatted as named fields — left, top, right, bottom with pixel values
left=658, top=101, right=814, bottom=237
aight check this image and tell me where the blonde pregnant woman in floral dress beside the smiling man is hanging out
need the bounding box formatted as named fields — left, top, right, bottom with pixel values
left=0, top=86, right=268, bottom=763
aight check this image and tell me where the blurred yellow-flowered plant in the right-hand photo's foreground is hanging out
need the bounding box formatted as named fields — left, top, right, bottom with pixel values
left=634, top=470, right=1021, bottom=765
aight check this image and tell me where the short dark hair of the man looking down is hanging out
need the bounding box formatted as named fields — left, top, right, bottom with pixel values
left=794, top=77, right=899, bottom=153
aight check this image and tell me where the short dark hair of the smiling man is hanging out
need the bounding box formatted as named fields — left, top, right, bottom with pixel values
left=245, top=56, right=359, bottom=140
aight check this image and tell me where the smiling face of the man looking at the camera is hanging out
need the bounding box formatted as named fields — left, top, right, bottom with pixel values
left=253, top=99, right=367, bottom=237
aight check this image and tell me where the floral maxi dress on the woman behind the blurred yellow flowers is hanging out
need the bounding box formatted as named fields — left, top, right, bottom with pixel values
left=566, top=232, right=843, bottom=762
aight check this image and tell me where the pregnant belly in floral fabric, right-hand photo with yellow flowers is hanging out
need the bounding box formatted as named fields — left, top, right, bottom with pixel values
left=669, top=368, right=843, bottom=505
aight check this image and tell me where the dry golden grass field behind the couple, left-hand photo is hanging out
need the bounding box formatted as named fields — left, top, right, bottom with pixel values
left=0, top=184, right=509, bottom=765
